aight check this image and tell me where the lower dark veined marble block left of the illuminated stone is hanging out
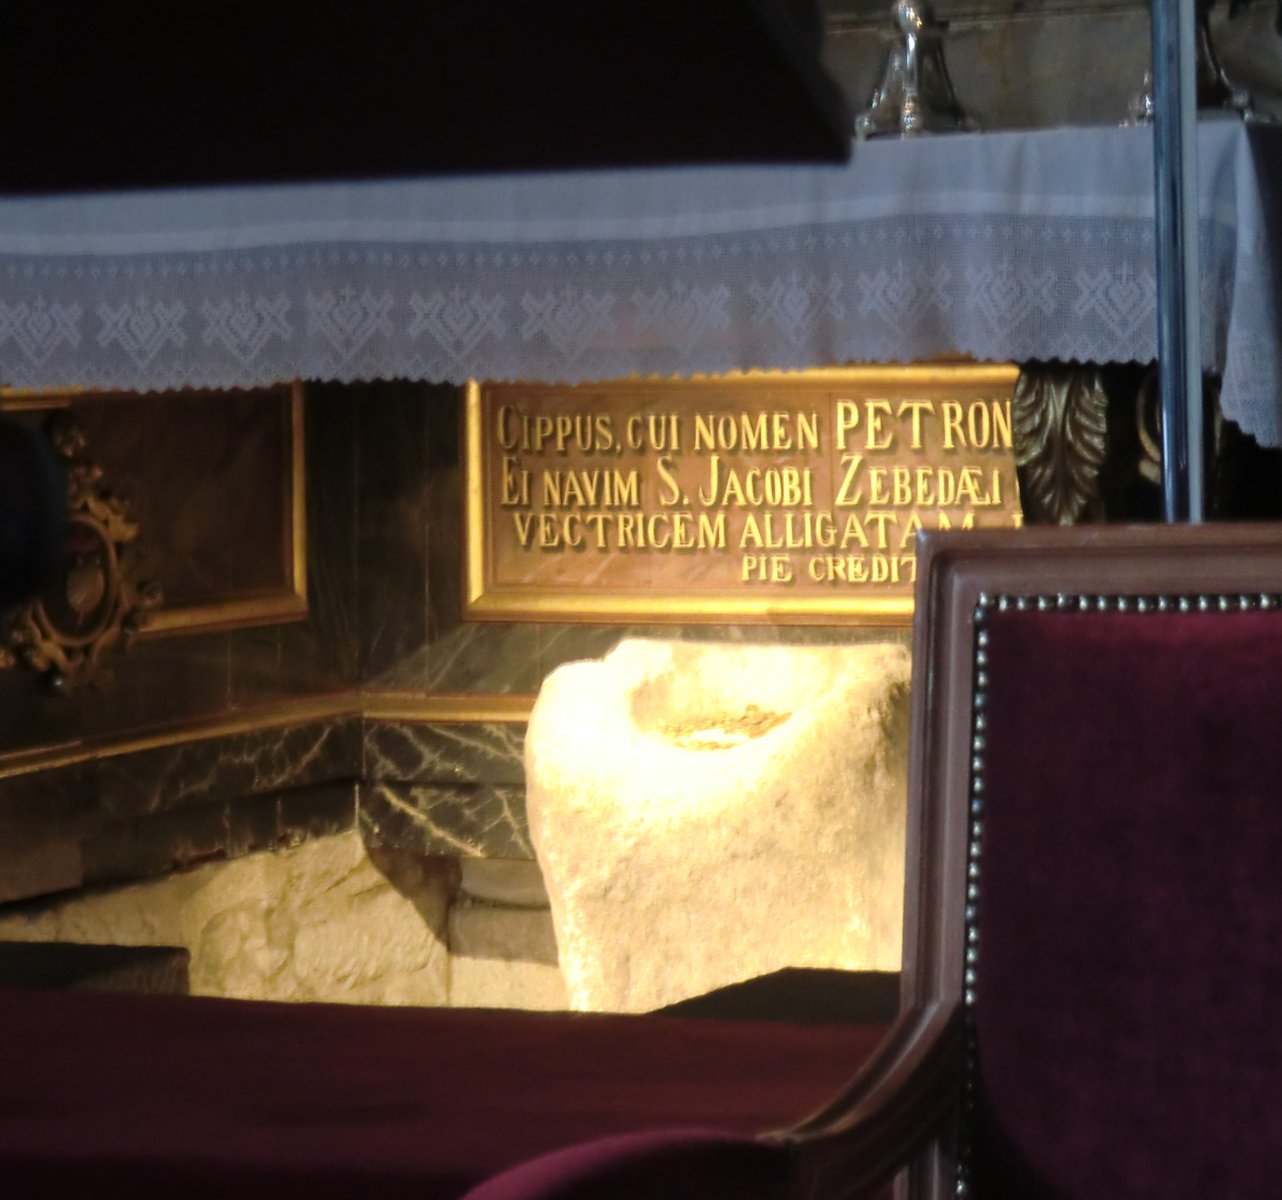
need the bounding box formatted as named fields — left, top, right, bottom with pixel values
left=359, top=783, right=535, bottom=859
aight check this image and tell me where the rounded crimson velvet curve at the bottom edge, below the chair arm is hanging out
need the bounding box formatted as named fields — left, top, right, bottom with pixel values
left=456, top=1129, right=788, bottom=1200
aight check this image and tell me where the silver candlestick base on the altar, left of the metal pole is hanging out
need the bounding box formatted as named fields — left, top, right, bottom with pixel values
left=855, top=0, right=977, bottom=138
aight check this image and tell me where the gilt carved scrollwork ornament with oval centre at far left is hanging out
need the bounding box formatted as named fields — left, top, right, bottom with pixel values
left=0, top=409, right=162, bottom=694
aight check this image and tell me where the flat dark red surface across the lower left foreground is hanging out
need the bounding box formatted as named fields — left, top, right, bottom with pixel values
left=0, top=991, right=882, bottom=1200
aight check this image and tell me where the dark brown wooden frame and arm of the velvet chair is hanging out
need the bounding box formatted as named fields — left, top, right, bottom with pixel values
left=778, top=524, right=1282, bottom=1200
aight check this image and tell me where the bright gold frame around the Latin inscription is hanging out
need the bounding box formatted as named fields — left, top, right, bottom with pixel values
left=460, top=363, right=1019, bottom=627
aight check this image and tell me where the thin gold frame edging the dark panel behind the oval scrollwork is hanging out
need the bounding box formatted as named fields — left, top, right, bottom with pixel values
left=0, top=381, right=308, bottom=638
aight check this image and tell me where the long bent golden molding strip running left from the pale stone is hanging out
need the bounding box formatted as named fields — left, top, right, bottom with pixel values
left=0, top=691, right=535, bottom=781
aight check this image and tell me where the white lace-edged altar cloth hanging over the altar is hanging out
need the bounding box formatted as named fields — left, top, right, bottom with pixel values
left=0, top=119, right=1282, bottom=445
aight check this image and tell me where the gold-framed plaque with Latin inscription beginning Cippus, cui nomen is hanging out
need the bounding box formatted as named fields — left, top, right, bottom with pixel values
left=464, top=364, right=1020, bottom=624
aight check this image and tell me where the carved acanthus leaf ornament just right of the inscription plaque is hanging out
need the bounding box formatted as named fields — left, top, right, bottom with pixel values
left=1010, top=367, right=1109, bottom=524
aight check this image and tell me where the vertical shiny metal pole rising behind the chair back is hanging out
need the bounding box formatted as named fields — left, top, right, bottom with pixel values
left=1151, top=0, right=1204, bottom=522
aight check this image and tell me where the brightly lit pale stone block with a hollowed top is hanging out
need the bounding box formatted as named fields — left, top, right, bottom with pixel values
left=526, top=640, right=909, bottom=1012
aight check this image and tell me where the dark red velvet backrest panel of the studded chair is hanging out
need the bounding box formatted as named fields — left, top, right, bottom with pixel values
left=976, top=612, right=1282, bottom=1200
